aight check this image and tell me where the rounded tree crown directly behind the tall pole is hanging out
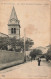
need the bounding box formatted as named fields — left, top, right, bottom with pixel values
left=20, top=38, right=34, bottom=51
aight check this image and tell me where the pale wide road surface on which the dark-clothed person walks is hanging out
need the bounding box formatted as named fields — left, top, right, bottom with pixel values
left=0, top=60, right=51, bottom=79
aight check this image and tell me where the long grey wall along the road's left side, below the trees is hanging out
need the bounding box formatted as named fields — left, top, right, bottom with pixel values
left=0, top=50, right=24, bottom=64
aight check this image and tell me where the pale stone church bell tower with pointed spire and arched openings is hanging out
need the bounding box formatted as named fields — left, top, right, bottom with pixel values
left=8, top=7, right=20, bottom=39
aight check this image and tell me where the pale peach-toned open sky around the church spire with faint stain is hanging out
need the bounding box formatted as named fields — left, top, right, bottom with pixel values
left=0, top=0, right=50, bottom=47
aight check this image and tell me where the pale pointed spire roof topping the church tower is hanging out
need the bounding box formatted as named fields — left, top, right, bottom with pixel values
left=8, top=7, right=19, bottom=25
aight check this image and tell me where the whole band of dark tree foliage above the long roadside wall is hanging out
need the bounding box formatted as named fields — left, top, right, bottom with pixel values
left=0, top=37, right=34, bottom=51
